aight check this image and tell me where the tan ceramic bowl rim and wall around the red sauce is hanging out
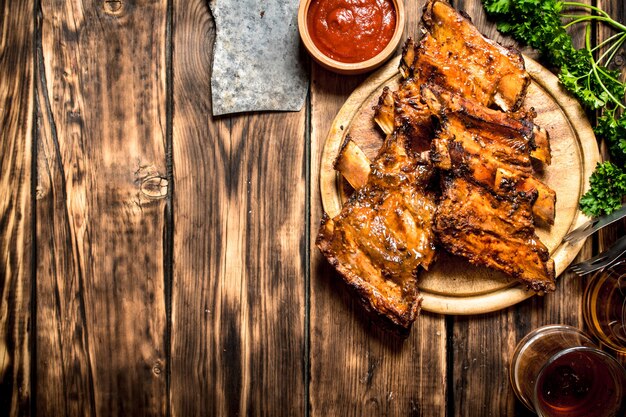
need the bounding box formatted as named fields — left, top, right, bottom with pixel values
left=298, top=0, right=406, bottom=74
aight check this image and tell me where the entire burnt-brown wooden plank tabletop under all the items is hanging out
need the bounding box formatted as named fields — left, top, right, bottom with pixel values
left=0, top=0, right=626, bottom=417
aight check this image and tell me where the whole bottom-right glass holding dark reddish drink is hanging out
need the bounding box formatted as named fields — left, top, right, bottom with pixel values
left=510, top=325, right=626, bottom=417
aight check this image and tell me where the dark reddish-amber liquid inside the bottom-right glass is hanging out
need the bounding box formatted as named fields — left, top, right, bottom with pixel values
left=535, top=350, right=626, bottom=417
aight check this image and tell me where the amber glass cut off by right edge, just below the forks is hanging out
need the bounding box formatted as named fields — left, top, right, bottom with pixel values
left=583, top=259, right=626, bottom=365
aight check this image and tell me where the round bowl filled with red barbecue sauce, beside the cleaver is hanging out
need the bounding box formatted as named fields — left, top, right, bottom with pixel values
left=298, top=0, right=405, bottom=74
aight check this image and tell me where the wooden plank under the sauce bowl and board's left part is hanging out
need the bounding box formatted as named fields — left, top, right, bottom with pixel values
left=309, top=1, right=446, bottom=416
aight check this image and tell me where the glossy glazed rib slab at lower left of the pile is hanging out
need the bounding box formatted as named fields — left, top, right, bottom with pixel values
left=316, top=115, right=435, bottom=329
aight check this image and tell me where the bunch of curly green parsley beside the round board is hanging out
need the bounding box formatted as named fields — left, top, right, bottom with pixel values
left=483, top=0, right=626, bottom=216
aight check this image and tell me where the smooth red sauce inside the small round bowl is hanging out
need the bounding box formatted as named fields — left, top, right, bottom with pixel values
left=307, top=0, right=396, bottom=63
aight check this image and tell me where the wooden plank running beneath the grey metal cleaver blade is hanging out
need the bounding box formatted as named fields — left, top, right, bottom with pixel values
left=170, top=0, right=307, bottom=416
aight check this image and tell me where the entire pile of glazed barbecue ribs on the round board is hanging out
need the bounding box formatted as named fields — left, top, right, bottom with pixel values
left=316, top=0, right=556, bottom=329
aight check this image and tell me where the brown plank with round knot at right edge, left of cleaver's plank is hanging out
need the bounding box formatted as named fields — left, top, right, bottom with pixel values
left=36, top=0, right=167, bottom=416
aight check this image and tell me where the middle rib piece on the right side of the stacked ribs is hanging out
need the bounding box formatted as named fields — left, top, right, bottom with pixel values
left=422, top=85, right=556, bottom=224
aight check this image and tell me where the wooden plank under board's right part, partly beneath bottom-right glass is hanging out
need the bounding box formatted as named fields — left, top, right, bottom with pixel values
left=449, top=0, right=592, bottom=416
